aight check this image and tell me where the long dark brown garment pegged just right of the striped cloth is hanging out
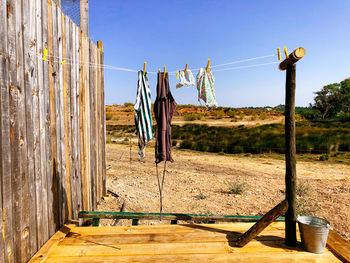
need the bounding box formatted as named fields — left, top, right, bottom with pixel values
left=154, top=72, right=176, bottom=163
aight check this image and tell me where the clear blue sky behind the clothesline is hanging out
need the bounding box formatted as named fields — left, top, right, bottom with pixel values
left=90, top=0, right=350, bottom=107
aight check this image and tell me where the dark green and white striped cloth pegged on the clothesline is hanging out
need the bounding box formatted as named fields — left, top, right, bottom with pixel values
left=134, top=71, right=153, bottom=158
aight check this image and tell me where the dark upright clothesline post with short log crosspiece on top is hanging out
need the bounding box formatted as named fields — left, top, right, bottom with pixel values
left=279, top=48, right=305, bottom=247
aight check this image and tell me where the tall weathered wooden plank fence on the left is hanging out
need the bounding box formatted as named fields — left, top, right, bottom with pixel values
left=0, top=0, right=106, bottom=262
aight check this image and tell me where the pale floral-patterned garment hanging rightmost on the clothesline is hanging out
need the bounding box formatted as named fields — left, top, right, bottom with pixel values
left=197, top=68, right=217, bottom=107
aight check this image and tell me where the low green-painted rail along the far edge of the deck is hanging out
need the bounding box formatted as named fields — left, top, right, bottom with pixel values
left=78, top=211, right=284, bottom=226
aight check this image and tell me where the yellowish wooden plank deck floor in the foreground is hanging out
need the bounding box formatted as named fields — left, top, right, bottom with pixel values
left=30, top=222, right=350, bottom=263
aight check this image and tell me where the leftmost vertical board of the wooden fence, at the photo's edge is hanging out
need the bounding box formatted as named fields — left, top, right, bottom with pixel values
left=0, top=0, right=15, bottom=263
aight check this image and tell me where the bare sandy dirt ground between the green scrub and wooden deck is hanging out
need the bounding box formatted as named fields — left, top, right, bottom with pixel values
left=99, top=144, right=350, bottom=240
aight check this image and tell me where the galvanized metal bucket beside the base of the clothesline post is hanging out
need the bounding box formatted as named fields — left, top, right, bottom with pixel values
left=297, top=216, right=331, bottom=253
